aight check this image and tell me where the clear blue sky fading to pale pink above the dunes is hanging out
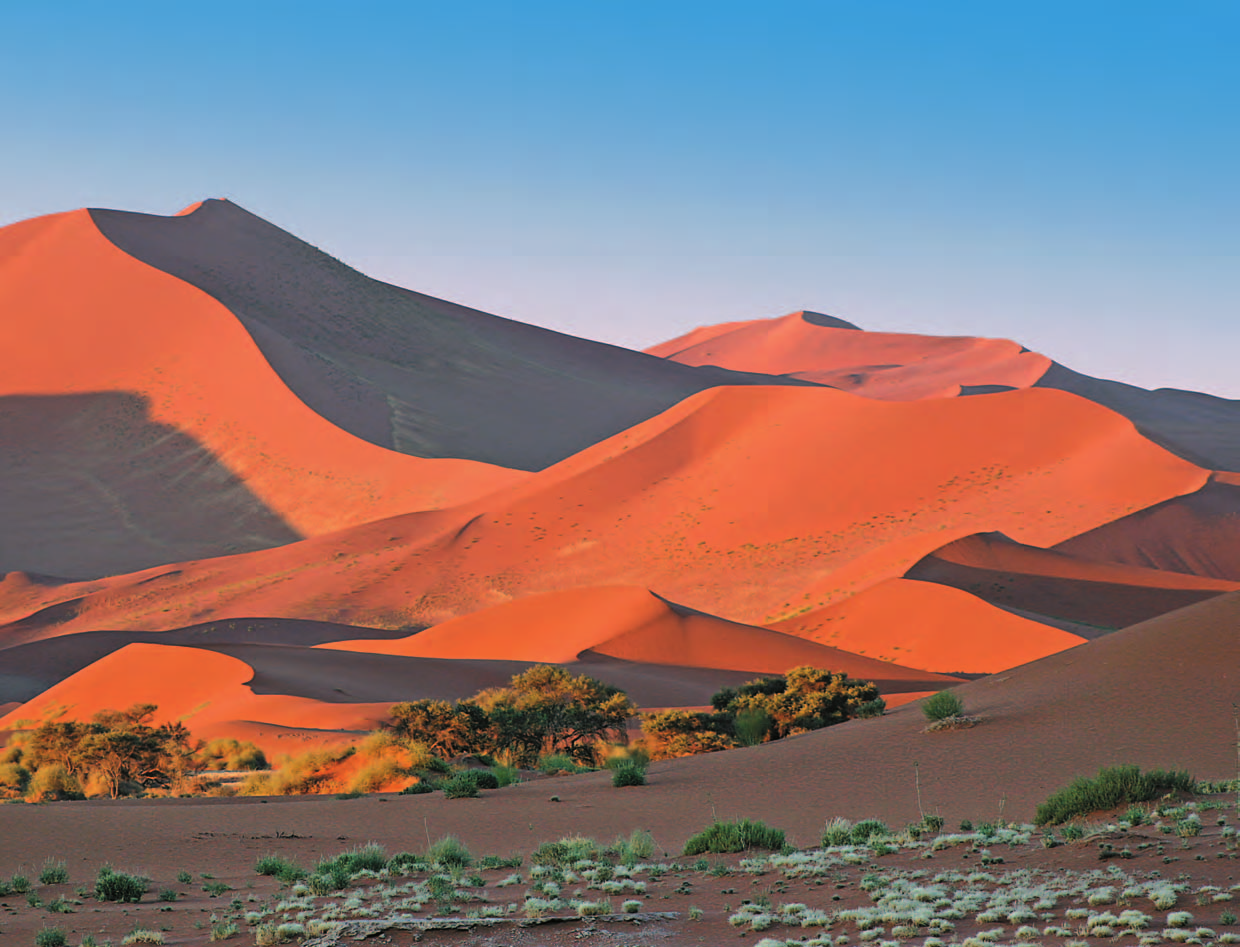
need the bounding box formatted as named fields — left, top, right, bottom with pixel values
left=0, top=0, right=1240, bottom=398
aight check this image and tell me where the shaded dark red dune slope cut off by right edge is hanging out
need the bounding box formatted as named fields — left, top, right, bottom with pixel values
left=1055, top=474, right=1240, bottom=581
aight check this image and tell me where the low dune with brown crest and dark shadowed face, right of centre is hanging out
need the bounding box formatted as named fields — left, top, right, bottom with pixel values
left=906, top=532, right=1240, bottom=637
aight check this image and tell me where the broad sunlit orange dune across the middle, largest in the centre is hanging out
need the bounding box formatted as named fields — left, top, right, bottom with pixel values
left=0, top=387, right=1208, bottom=634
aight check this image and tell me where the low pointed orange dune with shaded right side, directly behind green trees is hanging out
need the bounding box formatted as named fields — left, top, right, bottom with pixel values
left=319, top=586, right=947, bottom=690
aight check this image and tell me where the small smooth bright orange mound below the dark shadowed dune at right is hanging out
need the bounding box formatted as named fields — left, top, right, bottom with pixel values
left=770, top=579, right=1084, bottom=674
